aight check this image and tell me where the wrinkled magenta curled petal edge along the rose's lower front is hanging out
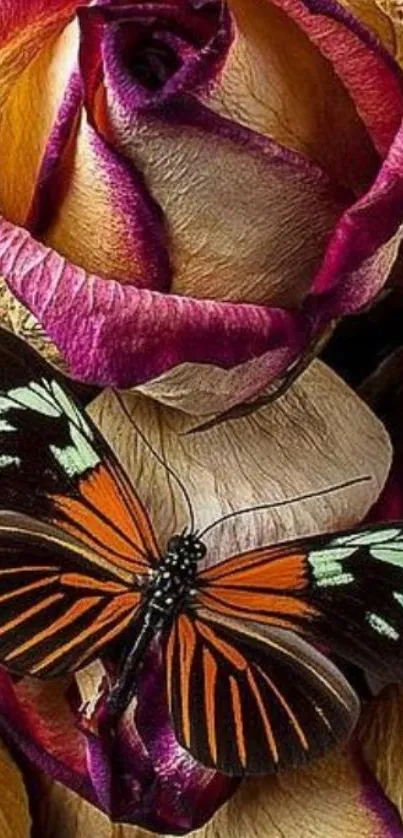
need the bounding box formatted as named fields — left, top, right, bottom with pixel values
left=0, top=220, right=305, bottom=387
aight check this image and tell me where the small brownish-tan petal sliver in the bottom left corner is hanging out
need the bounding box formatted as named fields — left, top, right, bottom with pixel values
left=0, top=744, right=31, bottom=838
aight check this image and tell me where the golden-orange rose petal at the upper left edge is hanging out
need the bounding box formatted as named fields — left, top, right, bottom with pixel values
left=0, top=10, right=77, bottom=224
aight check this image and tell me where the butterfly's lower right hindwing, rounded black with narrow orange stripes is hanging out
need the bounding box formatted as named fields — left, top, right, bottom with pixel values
left=166, top=609, right=358, bottom=776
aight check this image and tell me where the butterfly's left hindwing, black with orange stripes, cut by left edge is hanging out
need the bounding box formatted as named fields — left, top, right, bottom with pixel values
left=0, top=512, right=140, bottom=678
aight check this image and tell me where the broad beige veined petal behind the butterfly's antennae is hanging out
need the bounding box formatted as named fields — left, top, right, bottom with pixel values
left=92, top=361, right=391, bottom=559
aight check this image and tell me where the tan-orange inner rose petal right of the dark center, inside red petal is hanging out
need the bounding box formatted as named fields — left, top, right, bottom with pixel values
left=215, top=0, right=376, bottom=189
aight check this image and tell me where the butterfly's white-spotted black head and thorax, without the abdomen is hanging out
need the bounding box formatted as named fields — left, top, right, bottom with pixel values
left=145, top=533, right=206, bottom=625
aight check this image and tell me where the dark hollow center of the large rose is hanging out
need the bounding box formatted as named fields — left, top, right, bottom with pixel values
left=125, top=37, right=182, bottom=90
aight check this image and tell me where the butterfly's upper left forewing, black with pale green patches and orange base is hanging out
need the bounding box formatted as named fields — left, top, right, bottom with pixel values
left=0, top=330, right=159, bottom=573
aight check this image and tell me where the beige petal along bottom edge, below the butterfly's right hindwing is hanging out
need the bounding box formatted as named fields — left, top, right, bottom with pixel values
left=214, top=754, right=403, bottom=838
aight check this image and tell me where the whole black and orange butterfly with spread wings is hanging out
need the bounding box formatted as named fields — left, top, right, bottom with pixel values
left=0, top=330, right=403, bottom=776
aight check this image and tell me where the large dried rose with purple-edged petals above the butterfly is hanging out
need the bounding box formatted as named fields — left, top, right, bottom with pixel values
left=0, top=0, right=403, bottom=412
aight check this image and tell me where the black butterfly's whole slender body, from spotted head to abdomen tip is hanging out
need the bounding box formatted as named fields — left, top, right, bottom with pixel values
left=108, top=532, right=206, bottom=718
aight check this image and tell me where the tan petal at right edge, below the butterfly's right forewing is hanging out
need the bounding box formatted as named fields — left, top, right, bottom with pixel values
left=360, top=686, right=403, bottom=817
